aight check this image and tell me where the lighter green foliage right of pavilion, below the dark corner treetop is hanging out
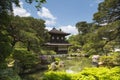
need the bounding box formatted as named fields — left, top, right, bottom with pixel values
left=73, top=20, right=120, bottom=54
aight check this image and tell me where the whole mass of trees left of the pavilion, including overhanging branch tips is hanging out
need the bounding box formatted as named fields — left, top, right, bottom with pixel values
left=0, top=0, right=48, bottom=80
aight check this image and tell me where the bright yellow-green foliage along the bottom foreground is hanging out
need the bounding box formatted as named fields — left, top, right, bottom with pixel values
left=43, top=67, right=120, bottom=80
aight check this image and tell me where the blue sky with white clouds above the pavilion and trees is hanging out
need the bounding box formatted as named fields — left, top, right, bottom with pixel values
left=13, top=0, right=103, bottom=34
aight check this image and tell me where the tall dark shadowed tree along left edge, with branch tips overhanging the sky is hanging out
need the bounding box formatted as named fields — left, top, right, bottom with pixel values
left=0, top=0, right=46, bottom=66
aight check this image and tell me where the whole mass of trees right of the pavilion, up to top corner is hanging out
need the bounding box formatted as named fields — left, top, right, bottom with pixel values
left=70, top=0, right=120, bottom=54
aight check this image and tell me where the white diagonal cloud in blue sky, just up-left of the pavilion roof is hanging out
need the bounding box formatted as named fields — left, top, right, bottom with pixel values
left=37, top=7, right=56, bottom=25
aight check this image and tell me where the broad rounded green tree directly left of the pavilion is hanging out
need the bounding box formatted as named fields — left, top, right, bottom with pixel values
left=7, top=16, right=49, bottom=53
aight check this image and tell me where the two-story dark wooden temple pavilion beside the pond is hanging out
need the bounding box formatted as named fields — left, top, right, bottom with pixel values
left=45, top=28, right=71, bottom=54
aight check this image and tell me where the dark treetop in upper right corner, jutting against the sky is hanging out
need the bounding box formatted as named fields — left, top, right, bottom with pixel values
left=93, top=0, right=120, bottom=24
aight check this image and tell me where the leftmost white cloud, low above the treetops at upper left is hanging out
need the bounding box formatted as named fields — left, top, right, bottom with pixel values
left=13, top=2, right=31, bottom=17
